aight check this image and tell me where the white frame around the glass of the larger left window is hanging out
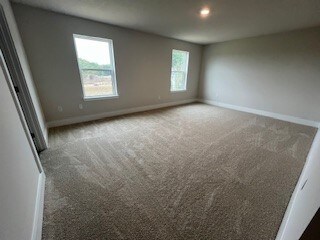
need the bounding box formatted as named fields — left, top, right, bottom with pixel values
left=73, top=34, right=119, bottom=101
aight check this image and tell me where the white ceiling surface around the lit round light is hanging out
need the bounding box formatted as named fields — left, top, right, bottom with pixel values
left=12, top=0, right=320, bottom=44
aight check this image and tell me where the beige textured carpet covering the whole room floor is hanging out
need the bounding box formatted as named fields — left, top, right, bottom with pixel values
left=41, top=104, right=316, bottom=240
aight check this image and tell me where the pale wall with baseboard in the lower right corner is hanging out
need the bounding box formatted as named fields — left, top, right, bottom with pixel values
left=276, top=130, right=320, bottom=240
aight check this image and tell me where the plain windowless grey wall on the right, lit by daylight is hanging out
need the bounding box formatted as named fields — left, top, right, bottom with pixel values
left=199, top=27, right=320, bottom=121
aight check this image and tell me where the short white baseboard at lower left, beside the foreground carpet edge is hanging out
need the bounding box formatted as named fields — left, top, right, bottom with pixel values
left=31, top=171, right=46, bottom=240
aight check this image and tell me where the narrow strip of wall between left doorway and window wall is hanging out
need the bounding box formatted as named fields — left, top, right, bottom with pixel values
left=0, top=0, right=48, bottom=145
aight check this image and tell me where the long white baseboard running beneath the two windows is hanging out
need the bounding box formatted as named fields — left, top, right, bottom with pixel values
left=47, top=99, right=197, bottom=128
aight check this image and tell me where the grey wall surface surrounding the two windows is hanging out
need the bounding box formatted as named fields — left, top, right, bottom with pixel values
left=13, top=4, right=202, bottom=121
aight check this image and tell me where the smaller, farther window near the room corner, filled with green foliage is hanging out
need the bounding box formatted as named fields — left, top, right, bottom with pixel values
left=171, top=49, right=189, bottom=92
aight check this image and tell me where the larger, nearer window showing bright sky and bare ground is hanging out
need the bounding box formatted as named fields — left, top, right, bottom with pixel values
left=73, top=34, right=118, bottom=99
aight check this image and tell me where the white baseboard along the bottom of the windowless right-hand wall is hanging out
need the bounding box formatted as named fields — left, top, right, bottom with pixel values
left=198, top=99, right=320, bottom=128
